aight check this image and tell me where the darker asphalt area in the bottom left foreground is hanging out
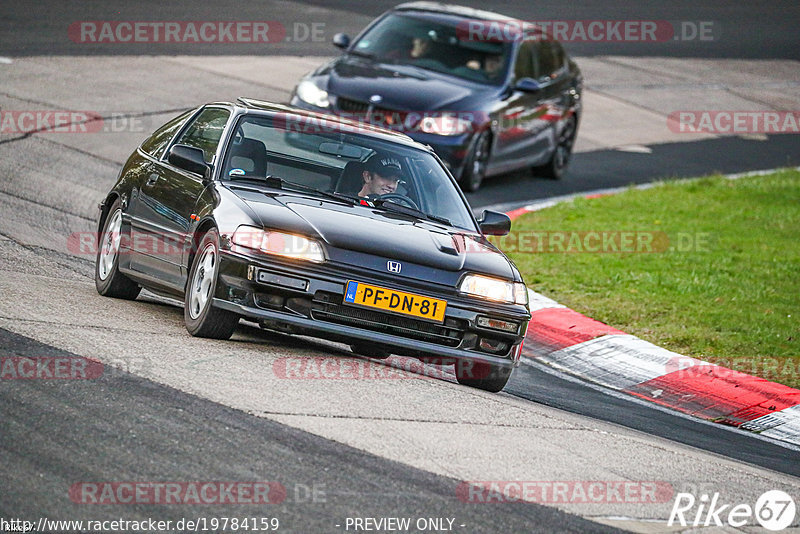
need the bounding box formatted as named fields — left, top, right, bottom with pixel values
left=0, top=329, right=616, bottom=533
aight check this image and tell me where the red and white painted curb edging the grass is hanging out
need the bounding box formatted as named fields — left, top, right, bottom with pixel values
left=508, top=171, right=800, bottom=445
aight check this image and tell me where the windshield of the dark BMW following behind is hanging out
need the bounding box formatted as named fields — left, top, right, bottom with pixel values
left=351, top=13, right=511, bottom=85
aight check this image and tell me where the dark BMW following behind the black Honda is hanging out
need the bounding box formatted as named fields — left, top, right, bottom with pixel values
left=292, top=2, right=583, bottom=191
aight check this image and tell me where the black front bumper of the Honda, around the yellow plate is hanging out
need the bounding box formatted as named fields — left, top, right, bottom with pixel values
left=213, top=250, right=530, bottom=367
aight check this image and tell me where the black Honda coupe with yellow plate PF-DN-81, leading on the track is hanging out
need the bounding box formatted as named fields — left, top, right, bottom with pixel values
left=95, top=99, right=530, bottom=391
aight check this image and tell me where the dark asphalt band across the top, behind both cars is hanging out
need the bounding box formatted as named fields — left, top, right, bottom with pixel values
left=0, top=0, right=800, bottom=59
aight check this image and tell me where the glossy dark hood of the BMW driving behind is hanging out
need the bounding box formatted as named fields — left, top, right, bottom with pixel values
left=322, top=56, right=484, bottom=112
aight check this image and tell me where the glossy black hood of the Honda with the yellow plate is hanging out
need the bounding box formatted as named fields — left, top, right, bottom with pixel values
left=237, top=192, right=515, bottom=280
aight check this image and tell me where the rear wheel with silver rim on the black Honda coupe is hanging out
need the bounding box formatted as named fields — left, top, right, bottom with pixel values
left=94, top=199, right=142, bottom=300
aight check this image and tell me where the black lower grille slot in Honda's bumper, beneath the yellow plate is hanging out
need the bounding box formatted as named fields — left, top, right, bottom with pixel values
left=311, top=302, right=464, bottom=347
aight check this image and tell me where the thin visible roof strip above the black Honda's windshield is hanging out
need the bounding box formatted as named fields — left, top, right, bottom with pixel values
left=227, top=97, right=433, bottom=152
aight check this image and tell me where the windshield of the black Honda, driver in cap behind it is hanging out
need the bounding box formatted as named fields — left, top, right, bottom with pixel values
left=222, top=114, right=477, bottom=232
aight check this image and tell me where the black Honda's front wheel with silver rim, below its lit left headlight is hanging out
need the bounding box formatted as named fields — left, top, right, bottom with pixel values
left=183, top=228, right=239, bottom=339
